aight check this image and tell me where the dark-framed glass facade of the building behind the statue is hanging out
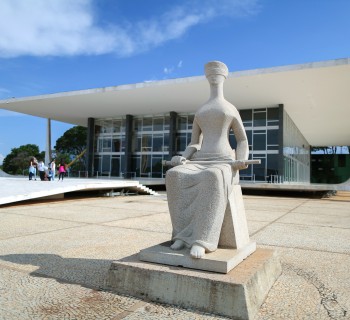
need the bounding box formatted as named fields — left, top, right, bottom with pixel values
left=93, top=106, right=310, bottom=182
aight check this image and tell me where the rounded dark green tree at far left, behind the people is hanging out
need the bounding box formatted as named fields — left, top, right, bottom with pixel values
left=3, top=144, right=45, bottom=174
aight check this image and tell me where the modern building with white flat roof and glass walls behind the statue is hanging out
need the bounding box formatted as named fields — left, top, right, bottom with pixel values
left=0, top=58, right=350, bottom=182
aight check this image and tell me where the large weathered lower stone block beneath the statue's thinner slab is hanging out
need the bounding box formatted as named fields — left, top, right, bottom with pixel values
left=106, top=249, right=282, bottom=319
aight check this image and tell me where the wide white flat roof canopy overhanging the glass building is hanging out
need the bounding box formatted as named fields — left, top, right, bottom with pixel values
left=0, top=58, right=350, bottom=146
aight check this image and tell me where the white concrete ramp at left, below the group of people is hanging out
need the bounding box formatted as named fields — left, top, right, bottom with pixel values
left=0, top=177, right=158, bottom=205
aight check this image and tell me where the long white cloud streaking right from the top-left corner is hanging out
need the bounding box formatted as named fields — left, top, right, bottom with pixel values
left=0, top=0, right=258, bottom=57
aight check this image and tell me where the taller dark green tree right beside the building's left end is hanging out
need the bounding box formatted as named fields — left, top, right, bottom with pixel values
left=55, top=126, right=87, bottom=170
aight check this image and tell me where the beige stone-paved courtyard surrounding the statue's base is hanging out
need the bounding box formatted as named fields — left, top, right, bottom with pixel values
left=0, top=193, right=350, bottom=320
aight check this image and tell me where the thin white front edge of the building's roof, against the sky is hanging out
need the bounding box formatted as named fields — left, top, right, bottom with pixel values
left=0, top=58, right=350, bottom=104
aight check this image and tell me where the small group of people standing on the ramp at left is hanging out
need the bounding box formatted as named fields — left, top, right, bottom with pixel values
left=29, top=157, right=67, bottom=181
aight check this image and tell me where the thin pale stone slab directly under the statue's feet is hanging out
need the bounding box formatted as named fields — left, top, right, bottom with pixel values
left=139, top=241, right=256, bottom=273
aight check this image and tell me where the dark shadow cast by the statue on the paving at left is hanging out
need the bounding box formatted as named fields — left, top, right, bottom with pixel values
left=0, top=253, right=112, bottom=289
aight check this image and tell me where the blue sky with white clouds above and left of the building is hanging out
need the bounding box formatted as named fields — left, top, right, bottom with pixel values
left=0, top=0, right=350, bottom=163
